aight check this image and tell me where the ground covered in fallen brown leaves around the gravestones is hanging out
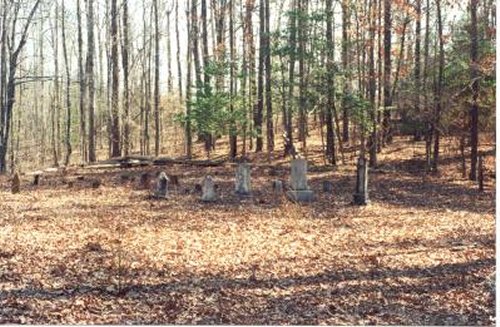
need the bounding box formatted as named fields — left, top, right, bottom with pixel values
left=0, top=134, right=495, bottom=325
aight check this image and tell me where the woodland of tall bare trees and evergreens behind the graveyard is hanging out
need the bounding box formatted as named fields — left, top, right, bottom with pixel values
left=0, top=0, right=496, bottom=179
